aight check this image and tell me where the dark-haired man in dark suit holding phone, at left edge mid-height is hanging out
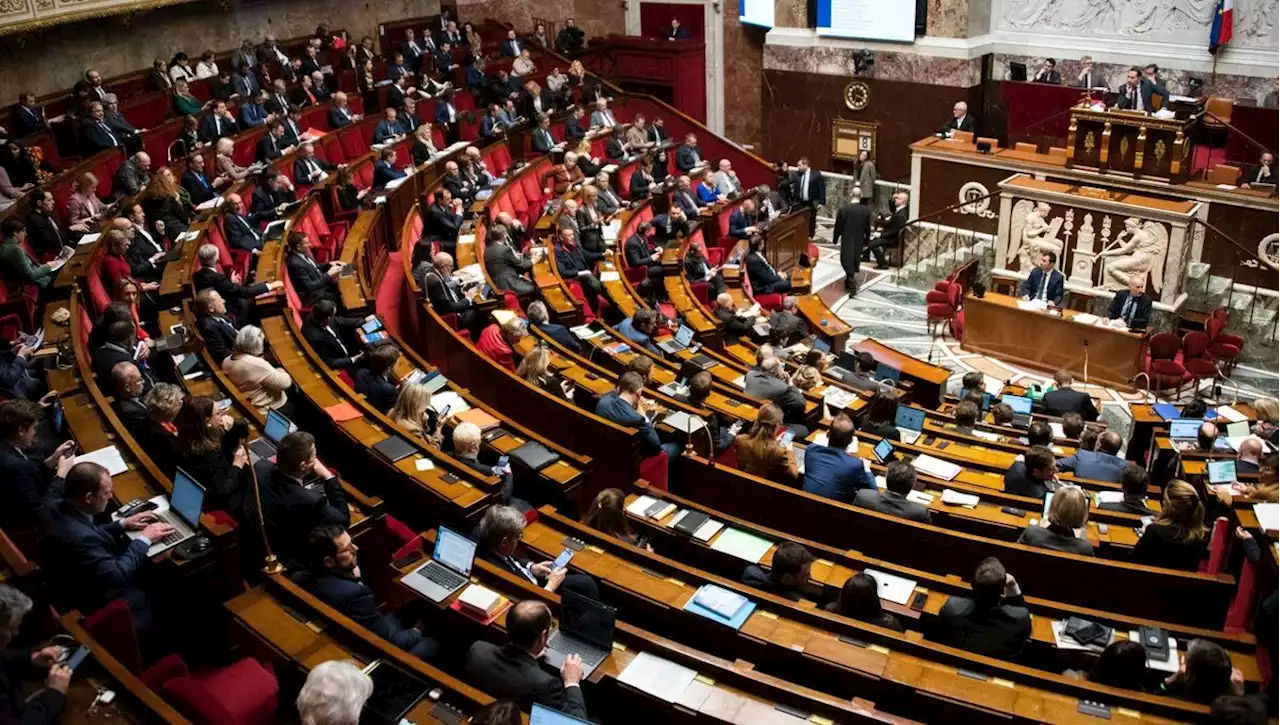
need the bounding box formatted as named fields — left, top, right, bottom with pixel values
left=0, top=398, right=76, bottom=534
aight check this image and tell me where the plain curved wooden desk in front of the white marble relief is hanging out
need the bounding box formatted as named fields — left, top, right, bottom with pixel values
left=960, top=292, right=1144, bottom=389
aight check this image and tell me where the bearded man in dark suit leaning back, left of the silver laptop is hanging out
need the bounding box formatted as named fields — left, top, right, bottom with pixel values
left=302, top=524, right=440, bottom=660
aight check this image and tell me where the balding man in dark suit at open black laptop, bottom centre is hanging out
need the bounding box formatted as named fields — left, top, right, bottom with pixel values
left=467, top=602, right=586, bottom=720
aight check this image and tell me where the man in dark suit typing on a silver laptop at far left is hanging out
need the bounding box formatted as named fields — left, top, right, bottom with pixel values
left=40, top=462, right=173, bottom=631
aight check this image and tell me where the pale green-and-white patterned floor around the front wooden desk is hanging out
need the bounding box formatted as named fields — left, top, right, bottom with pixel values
left=814, top=218, right=1280, bottom=439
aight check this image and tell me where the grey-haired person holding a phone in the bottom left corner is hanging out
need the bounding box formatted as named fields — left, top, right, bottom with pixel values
left=0, top=584, right=72, bottom=725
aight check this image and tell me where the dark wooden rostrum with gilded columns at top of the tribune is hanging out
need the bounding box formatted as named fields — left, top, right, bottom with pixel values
left=1066, top=105, right=1201, bottom=183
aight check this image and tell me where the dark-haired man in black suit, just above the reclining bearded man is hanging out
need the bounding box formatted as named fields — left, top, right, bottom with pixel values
left=241, top=430, right=351, bottom=569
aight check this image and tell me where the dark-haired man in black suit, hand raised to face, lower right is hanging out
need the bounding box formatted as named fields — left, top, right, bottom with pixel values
left=938, top=557, right=1032, bottom=660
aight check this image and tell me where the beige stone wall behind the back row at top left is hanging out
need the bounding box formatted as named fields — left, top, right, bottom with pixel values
left=0, top=0, right=440, bottom=104
